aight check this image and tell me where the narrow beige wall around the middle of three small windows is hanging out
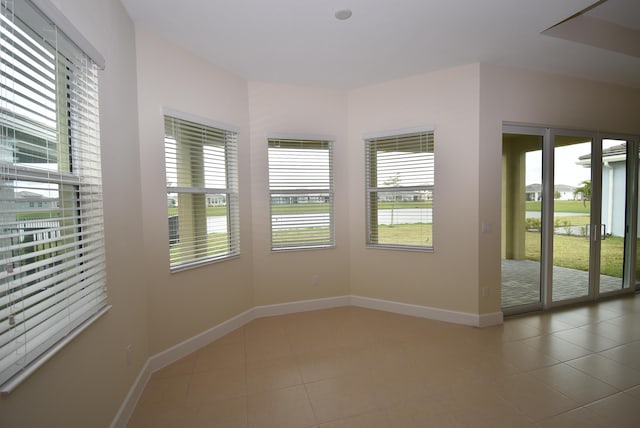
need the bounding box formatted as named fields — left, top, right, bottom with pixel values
left=249, top=82, right=350, bottom=305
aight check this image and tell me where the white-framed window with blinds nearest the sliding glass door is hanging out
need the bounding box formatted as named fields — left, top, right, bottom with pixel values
left=363, top=127, right=435, bottom=252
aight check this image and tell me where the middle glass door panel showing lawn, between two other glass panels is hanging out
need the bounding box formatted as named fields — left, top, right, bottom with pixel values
left=551, top=135, right=592, bottom=302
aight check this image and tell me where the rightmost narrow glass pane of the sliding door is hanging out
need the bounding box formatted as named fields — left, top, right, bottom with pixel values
left=600, top=140, right=628, bottom=293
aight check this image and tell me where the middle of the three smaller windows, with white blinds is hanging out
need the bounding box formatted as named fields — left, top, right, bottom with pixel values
left=269, top=138, right=335, bottom=250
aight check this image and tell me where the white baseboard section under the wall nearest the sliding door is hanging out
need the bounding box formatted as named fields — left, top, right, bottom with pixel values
left=350, top=296, right=502, bottom=327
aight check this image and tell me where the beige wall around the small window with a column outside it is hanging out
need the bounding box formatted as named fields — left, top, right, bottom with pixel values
left=136, top=29, right=252, bottom=355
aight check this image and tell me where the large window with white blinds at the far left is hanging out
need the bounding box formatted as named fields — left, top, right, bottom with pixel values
left=0, top=1, right=108, bottom=393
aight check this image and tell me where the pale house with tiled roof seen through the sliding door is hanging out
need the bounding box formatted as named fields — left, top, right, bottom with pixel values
left=577, top=142, right=627, bottom=236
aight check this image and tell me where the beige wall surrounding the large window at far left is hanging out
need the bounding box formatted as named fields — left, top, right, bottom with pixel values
left=0, top=0, right=149, bottom=428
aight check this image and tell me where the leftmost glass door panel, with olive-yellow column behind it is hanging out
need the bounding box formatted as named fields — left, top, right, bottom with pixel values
left=501, top=134, right=543, bottom=308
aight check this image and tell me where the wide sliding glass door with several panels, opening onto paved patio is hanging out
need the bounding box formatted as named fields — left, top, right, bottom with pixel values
left=501, top=126, right=640, bottom=314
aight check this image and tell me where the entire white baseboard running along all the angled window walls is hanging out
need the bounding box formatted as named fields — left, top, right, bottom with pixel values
left=111, top=296, right=503, bottom=428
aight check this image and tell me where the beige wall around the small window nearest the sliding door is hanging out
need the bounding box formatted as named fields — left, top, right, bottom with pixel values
left=348, top=65, right=480, bottom=313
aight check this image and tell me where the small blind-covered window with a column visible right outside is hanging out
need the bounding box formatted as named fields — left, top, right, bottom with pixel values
left=164, top=114, right=240, bottom=271
